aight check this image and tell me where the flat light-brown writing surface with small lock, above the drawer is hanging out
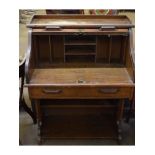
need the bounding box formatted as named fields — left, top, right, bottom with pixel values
left=29, top=68, right=134, bottom=86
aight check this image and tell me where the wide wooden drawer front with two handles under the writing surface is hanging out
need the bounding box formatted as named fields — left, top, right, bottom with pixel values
left=29, top=86, right=133, bottom=99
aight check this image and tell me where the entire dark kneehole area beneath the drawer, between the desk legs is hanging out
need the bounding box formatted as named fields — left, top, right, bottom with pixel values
left=40, top=100, right=118, bottom=139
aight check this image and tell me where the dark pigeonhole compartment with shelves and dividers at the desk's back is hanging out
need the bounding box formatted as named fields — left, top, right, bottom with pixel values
left=32, top=35, right=128, bottom=67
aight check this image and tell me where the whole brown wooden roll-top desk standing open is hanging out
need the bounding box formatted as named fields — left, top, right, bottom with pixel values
left=26, top=15, right=134, bottom=142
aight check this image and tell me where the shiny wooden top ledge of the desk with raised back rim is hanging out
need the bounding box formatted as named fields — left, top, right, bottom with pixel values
left=27, top=15, right=133, bottom=27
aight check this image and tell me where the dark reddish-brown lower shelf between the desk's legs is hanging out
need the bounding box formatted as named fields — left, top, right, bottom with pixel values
left=41, top=115, right=118, bottom=139
